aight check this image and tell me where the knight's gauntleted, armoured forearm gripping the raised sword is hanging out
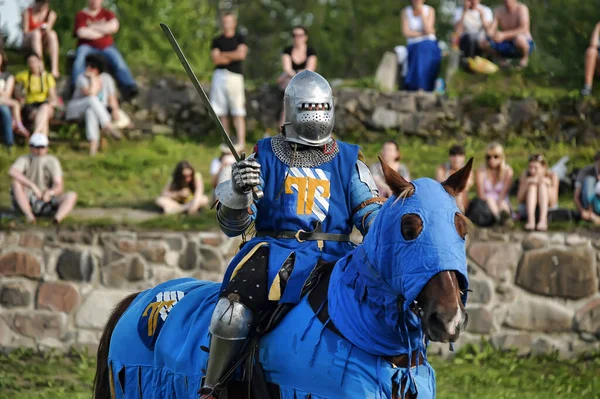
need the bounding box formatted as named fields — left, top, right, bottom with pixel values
left=215, top=154, right=261, bottom=237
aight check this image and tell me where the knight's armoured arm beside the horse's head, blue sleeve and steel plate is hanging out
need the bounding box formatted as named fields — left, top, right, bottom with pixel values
left=350, top=159, right=385, bottom=236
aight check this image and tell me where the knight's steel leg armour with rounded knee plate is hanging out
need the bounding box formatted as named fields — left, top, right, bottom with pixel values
left=200, top=294, right=253, bottom=399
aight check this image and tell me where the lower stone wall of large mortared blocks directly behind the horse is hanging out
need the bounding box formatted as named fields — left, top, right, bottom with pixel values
left=0, top=230, right=600, bottom=356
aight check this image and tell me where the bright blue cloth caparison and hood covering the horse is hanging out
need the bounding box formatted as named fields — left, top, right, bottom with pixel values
left=103, top=164, right=470, bottom=399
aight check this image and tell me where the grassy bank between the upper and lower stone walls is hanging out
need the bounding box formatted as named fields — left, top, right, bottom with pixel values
left=0, top=132, right=598, bottom=230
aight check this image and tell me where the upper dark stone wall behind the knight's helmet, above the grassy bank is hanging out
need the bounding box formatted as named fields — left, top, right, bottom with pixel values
left=133, top=79, right=600, bottom=143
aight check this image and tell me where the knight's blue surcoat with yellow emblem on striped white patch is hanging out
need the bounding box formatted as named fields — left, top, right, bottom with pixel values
left=222, top=138, right=366, bottom=303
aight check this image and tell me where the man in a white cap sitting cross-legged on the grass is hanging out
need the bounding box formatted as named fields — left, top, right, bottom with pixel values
left=8, top=133, right=77, bottom=223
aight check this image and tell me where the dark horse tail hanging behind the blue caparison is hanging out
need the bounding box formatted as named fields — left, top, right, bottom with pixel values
left=93, top=292, right=139, bottom=399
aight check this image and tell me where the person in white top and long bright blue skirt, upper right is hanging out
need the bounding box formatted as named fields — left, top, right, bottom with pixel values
left=402, top=0, right=442, bottom=91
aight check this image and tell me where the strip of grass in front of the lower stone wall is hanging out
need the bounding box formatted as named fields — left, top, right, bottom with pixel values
left=0, top=345, right=600, bottom=399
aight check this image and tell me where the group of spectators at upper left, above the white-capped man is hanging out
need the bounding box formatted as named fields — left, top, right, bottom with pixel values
left=0, top=0, right=138, bottom=155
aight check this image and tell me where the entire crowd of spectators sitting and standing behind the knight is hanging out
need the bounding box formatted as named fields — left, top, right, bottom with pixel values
left=0, top=0, right=600, bottom=231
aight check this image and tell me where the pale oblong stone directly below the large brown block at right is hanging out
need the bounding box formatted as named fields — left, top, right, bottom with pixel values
left=504, top=296, right=573, bottom=333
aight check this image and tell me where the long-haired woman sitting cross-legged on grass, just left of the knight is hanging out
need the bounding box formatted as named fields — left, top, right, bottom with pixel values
left=156, top=161, right=208, bottom=215
